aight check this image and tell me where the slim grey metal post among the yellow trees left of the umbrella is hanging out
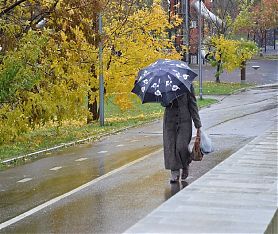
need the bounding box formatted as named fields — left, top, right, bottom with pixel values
left=98, top=13, right=104, bottom=126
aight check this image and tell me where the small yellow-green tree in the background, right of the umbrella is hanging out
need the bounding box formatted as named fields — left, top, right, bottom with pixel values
left=199, top=0, right=257, bottom=82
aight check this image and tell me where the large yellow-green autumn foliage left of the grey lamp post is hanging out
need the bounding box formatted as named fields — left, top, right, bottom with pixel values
left=0, top=1, right=100, bottom=143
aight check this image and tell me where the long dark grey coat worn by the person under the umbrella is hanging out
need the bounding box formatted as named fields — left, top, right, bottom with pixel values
left=163, top=87, right=202, bottom=170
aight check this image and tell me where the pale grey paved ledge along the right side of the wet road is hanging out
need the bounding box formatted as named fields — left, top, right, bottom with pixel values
left=125, top=125, right=278, bottom=233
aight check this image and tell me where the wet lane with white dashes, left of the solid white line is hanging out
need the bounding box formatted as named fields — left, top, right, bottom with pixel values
left=0, top=125, right=162, bottom=222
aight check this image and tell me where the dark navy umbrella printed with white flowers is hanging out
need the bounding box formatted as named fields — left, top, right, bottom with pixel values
left=131, top=59, right=197, bottom=106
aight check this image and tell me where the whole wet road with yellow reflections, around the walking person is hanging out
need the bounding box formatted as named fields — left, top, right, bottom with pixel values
left=0, top=87, right=277, bottom=233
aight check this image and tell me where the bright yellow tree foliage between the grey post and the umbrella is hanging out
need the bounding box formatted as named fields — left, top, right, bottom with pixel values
left=104, top=1, right=180, bottom=109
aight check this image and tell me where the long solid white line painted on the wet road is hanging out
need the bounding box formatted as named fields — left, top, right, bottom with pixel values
left=0, top=148, right=162, bottom=230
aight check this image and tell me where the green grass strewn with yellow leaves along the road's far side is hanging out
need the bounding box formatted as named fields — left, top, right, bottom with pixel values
left=0, top=82, right=252, bottom=165
